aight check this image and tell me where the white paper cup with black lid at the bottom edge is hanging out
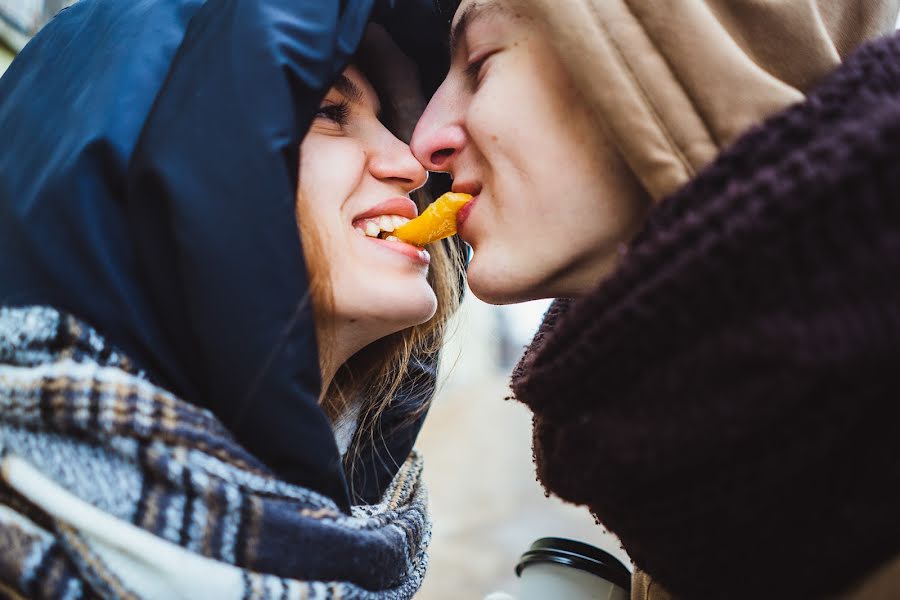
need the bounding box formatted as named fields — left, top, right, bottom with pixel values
left=516, top=538, right=631, bottom=600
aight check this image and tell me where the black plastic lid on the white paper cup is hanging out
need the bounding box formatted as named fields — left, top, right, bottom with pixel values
left=516, top=538, right=631, bottom=592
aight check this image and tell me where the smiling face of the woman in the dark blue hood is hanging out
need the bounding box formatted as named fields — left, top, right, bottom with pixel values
left=297, top=66, right=437, bottom=347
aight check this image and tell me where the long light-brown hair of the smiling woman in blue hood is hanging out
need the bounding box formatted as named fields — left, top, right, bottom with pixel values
left=297, top=38, right=465, bottom=491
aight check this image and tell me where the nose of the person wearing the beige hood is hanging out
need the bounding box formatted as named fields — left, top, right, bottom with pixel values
left=409, top=82, right=466, bottom=172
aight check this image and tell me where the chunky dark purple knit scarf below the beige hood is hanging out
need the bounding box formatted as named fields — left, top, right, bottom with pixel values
left=513, top=31, right=900, bottom=600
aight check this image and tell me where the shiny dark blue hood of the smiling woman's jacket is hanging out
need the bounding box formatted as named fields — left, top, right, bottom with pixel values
left=0, top=0, right=446, bottom=509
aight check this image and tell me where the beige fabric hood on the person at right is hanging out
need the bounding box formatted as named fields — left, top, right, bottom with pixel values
left=514, top=0, right=900, bottom=199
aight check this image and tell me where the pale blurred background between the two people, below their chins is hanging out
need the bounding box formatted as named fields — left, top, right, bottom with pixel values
left=417, top=294, right=630, bottom=600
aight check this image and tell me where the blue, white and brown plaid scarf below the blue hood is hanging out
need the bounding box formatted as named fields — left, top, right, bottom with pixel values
left=0, top=307, right=431, bottom=600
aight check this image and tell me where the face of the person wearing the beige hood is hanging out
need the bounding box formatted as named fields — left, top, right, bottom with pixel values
left=411, top=0, right=649, bottom=303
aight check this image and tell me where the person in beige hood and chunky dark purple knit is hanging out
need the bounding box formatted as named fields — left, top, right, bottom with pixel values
left=411, top=0, right=900, bottom=599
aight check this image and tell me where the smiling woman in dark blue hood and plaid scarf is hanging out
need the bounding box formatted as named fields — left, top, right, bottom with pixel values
left=0, top=0, right=458, bottom=599
